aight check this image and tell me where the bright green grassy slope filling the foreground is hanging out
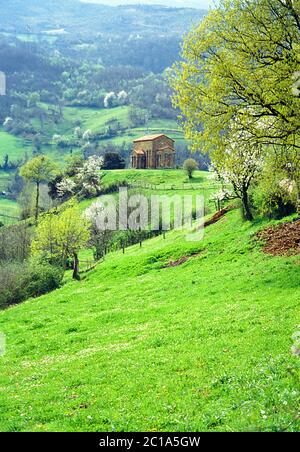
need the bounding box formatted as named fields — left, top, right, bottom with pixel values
left=0, top=205, right=300, bottom=431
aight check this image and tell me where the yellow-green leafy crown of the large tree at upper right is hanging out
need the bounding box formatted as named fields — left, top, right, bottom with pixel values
left=173, top=0, right=300, bottom=151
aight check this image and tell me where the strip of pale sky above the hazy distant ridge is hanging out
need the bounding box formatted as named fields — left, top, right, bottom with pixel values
left=81, top=0, right=213, bottom=9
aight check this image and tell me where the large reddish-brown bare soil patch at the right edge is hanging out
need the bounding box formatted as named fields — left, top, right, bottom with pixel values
left=257, top=219, right=300, bottom=256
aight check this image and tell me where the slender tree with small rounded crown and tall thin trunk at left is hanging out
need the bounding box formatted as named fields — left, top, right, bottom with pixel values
left=20, top=155, right=56, bottom=223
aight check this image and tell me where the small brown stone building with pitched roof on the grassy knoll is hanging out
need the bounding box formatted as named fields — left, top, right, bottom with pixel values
left=131, top=135, right=176, bottom=169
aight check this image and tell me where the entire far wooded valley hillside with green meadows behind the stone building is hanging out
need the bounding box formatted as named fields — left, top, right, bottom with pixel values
left=0, top=0, right=207, bottom=218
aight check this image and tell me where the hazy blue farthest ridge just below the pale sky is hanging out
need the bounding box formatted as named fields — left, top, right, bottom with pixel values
left=0, top=0, right=205, bottom=36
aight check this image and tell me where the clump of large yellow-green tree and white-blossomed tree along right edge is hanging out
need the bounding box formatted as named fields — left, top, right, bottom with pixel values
left=171, top=0, right=300, bottom=220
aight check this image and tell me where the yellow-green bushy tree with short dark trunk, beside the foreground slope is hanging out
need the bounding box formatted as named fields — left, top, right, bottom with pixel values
left=31, top=202, right=90, bottom=280
